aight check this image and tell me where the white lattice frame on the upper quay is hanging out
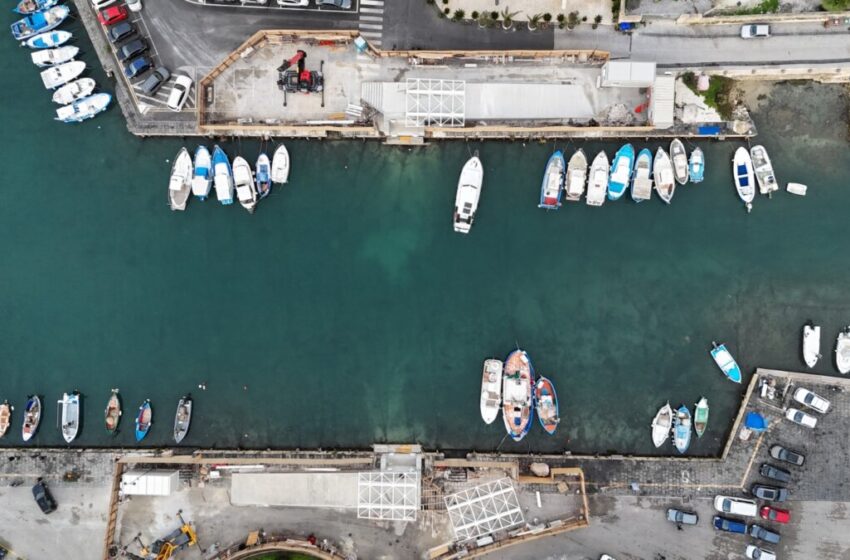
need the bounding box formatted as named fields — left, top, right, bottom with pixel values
left=404, top=78, right=466, bottom=127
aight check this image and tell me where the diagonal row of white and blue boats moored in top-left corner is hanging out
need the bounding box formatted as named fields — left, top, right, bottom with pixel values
left=12, top=0, right=112, bottom=123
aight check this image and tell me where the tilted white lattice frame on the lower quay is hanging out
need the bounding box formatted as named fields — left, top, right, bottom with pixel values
left=445, top=478, right=525, bottom=541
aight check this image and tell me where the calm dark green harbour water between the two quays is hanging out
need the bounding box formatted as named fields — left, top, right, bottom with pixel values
left=0, top=16, right=850, bottom=454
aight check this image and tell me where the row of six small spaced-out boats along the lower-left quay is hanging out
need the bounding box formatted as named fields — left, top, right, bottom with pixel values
left=0, top=389, right=192, bottom=443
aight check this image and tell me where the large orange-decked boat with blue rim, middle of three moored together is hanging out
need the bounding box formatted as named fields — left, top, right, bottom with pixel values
left=502, top=349, right=534, bottom=441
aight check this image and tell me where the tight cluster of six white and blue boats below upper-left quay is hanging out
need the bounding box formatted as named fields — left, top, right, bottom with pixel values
left=168, top=144, right=289, bottom=213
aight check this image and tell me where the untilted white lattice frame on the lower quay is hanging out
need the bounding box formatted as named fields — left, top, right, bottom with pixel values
left=357, top=471, right=422, bottom=521
